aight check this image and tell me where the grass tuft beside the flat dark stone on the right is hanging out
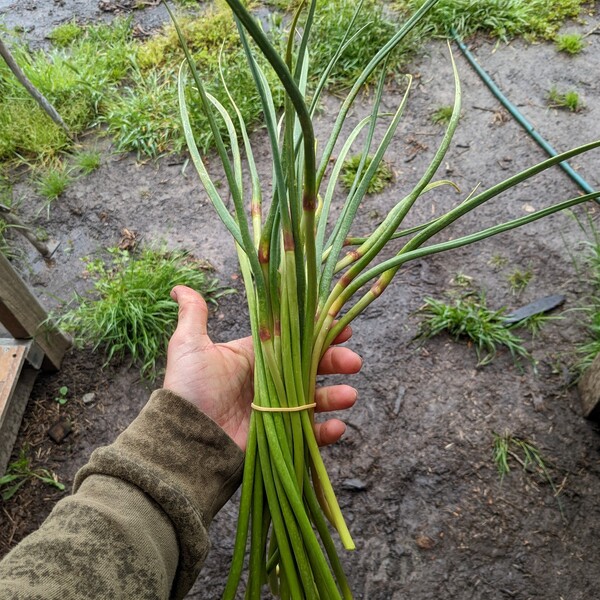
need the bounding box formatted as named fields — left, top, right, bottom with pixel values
left=419, top=294, right=529, bottom=366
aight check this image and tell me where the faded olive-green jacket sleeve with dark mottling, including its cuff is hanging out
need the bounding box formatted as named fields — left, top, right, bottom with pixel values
left=0, top=390, right=244, bottom=600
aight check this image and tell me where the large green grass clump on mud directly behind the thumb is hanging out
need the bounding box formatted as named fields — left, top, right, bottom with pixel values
left=57, top=248, right=229, bottom=378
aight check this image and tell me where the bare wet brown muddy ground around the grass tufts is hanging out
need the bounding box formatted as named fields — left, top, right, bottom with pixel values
left=0, top=0, right=600, bottom=600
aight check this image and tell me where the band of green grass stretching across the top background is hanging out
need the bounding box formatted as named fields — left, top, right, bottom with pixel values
left=0, top=0, right=580, bottom=162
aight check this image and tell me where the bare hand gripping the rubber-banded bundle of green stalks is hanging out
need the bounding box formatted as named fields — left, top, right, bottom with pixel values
left=163, top=285, right=362, bottom=450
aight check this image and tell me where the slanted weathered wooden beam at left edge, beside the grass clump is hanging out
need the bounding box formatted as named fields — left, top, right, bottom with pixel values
left=0, top=252, right=71, bottom=369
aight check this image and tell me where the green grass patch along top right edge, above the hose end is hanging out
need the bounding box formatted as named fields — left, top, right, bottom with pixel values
left=393, top=0, right=583, bottom=40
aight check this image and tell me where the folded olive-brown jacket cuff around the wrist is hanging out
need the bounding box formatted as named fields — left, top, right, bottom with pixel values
left=74, top=389, right=244, bottom=596
